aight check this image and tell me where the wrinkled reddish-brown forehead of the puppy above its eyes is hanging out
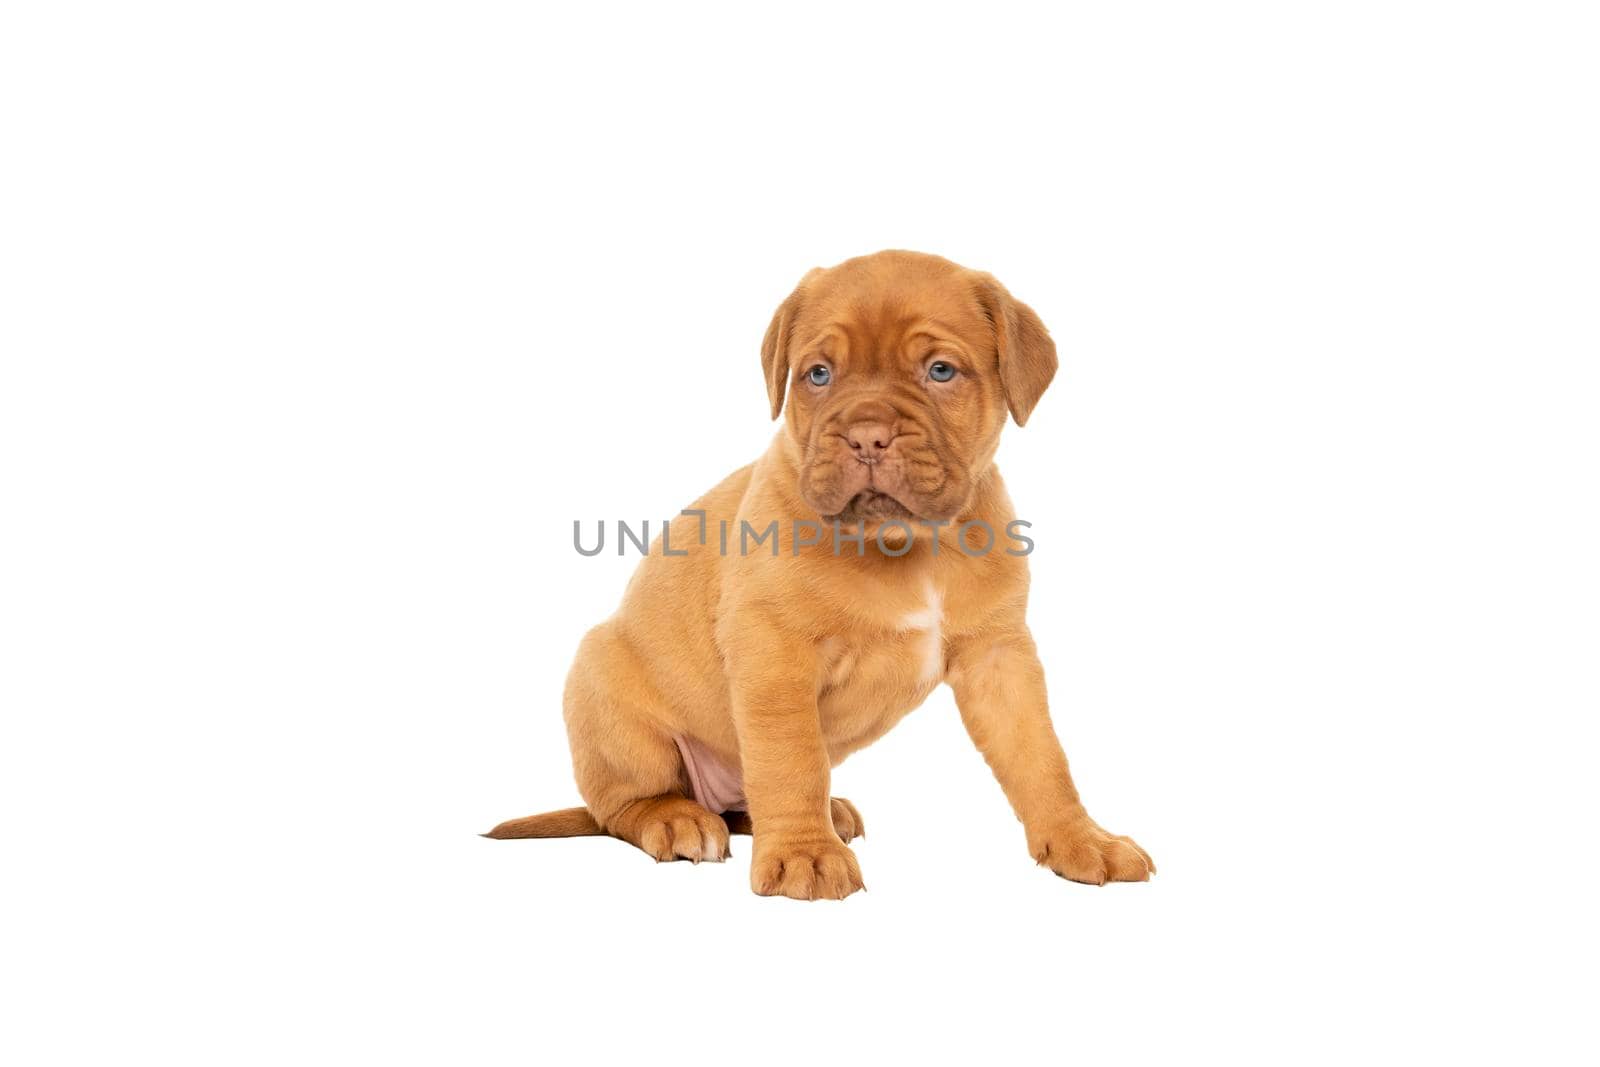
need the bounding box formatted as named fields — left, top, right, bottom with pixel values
left=794, top=269, right=992, bottom=363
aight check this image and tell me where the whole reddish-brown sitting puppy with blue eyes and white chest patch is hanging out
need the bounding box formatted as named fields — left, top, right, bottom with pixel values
left=486, top=251, right=1155, bottom=899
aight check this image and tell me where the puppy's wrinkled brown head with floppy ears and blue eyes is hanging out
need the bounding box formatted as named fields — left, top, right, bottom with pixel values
left=762, top=251, right=1056, bottom=523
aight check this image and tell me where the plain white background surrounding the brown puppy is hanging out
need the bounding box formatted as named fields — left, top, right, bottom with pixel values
left=0, top=3, right=1600, bottom=1064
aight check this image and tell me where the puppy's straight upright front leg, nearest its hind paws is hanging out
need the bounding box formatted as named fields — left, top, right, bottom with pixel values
left=722, top=613, right=866, bottom=901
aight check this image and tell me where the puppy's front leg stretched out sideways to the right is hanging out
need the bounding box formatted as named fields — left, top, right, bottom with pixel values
left=947, top=625, right=1155, bottom=885
